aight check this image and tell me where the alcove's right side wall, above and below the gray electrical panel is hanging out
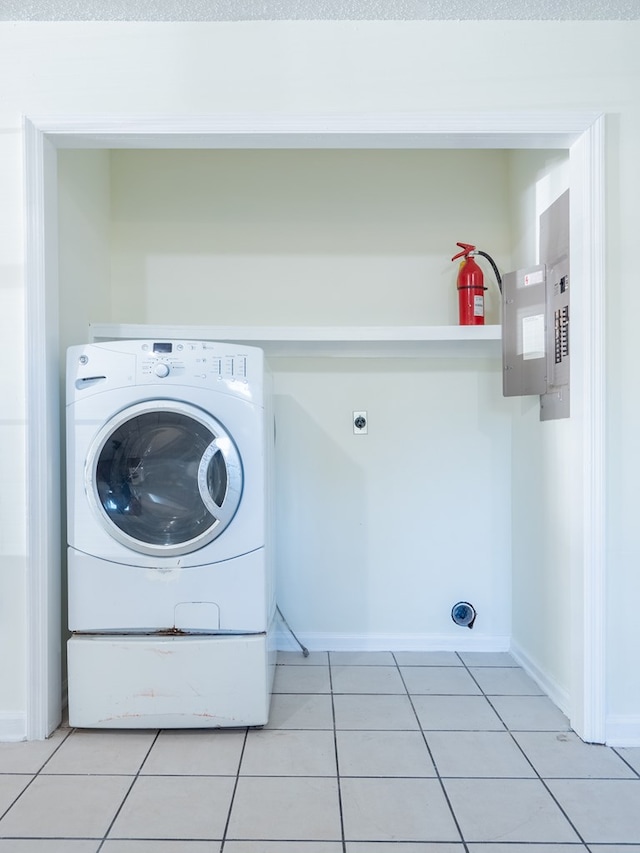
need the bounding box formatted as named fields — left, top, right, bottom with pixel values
left=509, top=151, right=580, bottom=711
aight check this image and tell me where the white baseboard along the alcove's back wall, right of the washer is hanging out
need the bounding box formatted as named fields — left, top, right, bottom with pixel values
left=276, top=626, right=509, bottom=652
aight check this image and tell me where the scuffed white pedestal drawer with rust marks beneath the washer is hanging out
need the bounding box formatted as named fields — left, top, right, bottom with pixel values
left=67, top=634, right=275, bottom=729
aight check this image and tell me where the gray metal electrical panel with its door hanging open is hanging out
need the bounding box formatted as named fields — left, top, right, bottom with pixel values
left=502, top=190, right=570, bottom=421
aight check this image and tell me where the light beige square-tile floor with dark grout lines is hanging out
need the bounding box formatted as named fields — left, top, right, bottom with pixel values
left=0, top=652, right=640, bottom=853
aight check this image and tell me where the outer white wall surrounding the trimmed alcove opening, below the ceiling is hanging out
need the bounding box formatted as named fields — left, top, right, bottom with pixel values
left=0, top=21, right=640, bottom=731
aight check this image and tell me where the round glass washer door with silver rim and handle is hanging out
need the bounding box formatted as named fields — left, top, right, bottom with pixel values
left=84, top=400, right=243, bottom=556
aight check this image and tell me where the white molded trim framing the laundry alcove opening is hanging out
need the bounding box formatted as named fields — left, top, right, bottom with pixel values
left=25, top=113, right=604, bottom=742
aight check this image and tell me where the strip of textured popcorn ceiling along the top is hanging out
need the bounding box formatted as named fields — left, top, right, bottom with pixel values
left=0, top=0, right=640, bottom=21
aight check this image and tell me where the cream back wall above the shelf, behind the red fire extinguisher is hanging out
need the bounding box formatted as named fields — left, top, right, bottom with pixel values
left=111, top=150, right=509, bottom=325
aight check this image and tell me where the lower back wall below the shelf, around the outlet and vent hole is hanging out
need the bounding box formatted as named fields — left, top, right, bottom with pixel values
left=275, top=359, right=511, bottom=650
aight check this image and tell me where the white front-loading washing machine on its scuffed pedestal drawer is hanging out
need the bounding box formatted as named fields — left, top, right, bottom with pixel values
left=67, top=340, right=275, bottom=728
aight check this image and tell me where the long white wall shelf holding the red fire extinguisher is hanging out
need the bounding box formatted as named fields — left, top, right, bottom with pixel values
left=89, top=323, right=501, bottom=358
